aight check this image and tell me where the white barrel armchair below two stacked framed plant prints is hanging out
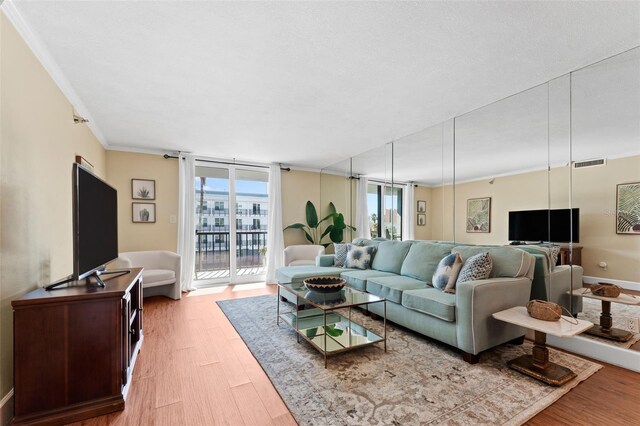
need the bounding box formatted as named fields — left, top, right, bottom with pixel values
left=115, top=250, right=181, bottom=300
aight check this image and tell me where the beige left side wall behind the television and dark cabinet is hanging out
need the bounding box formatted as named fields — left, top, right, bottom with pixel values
left=0, top=15, right=106, bottom=398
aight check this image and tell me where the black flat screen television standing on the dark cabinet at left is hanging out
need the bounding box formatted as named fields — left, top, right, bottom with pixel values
left=73, top=164, right=118, bottom=280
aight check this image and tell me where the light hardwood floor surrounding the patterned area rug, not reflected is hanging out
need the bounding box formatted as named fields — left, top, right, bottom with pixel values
left=78, top=285, right=640, bottom=426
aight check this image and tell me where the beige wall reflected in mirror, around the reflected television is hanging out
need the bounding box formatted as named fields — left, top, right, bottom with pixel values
left=452, top=156, right=640, bottom=282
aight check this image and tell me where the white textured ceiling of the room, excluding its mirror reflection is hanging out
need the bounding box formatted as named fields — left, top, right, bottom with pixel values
left=6, top=1, right=640, bottom=168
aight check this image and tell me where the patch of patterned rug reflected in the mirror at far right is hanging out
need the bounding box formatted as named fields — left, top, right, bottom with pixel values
left=578, top=297, right=640, bottom=349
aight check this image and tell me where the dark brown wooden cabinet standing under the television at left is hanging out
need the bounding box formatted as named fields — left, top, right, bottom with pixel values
left=11, top=268, right=143, bottom=424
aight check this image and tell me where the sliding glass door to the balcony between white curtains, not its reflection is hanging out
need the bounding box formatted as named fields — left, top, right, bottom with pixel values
left=194, top=162, right=269, bottom=287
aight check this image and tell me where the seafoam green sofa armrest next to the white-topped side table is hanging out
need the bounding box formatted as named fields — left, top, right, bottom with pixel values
left=456, top=277, right=531, bottom=354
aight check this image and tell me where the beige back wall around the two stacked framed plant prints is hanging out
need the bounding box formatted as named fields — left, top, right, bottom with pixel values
left=107, top=151, right=178, bottom=252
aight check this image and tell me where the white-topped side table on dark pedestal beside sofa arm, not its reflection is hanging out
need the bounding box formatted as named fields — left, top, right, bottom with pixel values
left=493, top=306, right=593, bottom=386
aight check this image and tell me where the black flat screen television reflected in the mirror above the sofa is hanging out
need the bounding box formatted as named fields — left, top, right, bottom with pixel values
left=509, top=209, right=580, bottom=243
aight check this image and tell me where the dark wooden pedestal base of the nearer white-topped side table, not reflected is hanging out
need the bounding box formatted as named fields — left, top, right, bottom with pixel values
left=507, top=330, right=576, bottom=386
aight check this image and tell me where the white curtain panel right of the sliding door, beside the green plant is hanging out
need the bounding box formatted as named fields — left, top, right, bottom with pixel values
left=266, top=165, right=284, bottom=283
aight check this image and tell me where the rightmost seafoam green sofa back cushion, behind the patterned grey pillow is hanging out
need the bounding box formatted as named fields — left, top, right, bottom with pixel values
left=452, top=246, right=531, bottom=278
